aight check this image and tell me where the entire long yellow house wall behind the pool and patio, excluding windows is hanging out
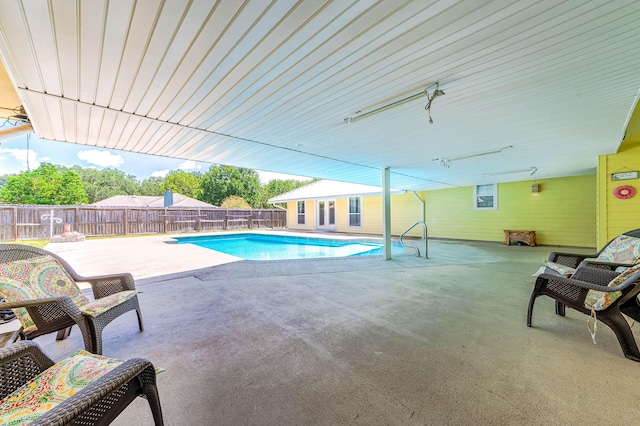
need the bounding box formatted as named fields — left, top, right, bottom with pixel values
left=287, top=173, right=596, bottom=248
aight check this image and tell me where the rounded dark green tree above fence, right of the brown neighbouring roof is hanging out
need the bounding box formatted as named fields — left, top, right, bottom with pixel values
left=199, top=166, right=260, bottom=207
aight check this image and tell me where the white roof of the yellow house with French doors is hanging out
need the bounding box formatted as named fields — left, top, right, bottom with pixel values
left=269, top=180, right=406, bottom=203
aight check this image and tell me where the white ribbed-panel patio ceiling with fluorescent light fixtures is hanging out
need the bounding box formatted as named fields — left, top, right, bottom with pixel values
left=0, top=0, right=640, bottom=190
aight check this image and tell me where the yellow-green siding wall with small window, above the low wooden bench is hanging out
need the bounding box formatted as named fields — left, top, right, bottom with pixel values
left=426, top=174, right=597, bottom=247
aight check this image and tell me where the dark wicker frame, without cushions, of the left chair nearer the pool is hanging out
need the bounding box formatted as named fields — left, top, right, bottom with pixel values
left=0, top=244, right=144, bottom=354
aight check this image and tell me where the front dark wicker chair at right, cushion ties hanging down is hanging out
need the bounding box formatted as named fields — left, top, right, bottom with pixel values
left=527, top=263, right=640, bottom=361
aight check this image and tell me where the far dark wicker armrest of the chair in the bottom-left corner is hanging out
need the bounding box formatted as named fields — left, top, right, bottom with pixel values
left=0, top=341, right=54, bottom=399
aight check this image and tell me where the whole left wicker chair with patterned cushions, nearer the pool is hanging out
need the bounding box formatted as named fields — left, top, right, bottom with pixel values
left=0, top=244, right=144, bottom=354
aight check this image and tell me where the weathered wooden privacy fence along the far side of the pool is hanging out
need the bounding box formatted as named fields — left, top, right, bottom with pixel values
left=0, top=204, right=287, bottom=241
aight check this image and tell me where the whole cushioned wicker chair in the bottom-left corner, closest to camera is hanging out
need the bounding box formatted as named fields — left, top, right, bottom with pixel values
left=0, top=341, right=163, bottom=426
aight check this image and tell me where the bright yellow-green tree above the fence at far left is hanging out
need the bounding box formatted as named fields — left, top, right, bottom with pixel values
left=0, top=163, right=88, bottom=205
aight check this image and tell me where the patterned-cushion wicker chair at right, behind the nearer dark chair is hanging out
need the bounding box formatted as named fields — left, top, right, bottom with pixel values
left=547, top=229, right=640, bottom=275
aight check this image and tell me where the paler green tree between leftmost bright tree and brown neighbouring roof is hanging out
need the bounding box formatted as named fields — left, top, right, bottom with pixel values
left=73, top=166, right=140, bottom=204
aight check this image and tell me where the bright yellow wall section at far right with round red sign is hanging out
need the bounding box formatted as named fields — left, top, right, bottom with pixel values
left=597, top=143, right=640, bottom=248
